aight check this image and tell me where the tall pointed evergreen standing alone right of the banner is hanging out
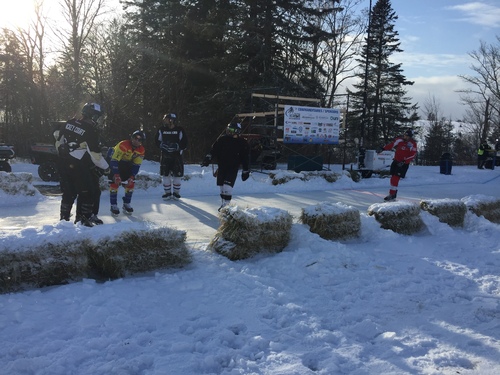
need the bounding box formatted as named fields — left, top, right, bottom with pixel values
left=349, top=0, right=418, bottom=147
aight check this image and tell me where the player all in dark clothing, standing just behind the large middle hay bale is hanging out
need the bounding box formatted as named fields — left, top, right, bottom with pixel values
left=201, top=122, right=250, bottom=211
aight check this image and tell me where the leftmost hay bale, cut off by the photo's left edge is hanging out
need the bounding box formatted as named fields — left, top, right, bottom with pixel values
left=0, top=239, right=91, bottom=293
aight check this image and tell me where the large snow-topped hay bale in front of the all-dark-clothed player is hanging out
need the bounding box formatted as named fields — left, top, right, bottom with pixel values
left=208, top=206, right=292, bottom=260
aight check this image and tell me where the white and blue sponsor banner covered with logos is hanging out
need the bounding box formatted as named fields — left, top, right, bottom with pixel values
left=283, top=105, right=340, bottom=145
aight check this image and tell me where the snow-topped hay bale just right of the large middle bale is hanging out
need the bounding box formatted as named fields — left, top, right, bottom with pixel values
left=300, top=202, right=361, bottom=240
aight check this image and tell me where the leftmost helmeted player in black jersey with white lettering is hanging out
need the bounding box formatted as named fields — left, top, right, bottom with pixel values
left=54, top=103, right=108, bottom=227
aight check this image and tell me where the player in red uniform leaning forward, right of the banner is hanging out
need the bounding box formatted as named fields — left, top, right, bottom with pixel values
left=378, top=129, right=417, bottom=201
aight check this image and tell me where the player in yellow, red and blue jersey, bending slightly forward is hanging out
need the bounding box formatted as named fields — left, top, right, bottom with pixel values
left=105, top=130, right=146, bottom=216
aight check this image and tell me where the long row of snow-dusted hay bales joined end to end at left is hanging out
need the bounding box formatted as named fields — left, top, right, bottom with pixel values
left=0, top=228, right=191, bottom=293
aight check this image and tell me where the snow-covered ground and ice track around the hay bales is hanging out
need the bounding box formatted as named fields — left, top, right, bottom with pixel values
left=0, top=161, right=500, bottom=375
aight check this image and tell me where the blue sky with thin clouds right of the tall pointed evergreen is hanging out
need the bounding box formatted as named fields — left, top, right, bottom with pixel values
left=390, top=0, right=500, bottom=120
